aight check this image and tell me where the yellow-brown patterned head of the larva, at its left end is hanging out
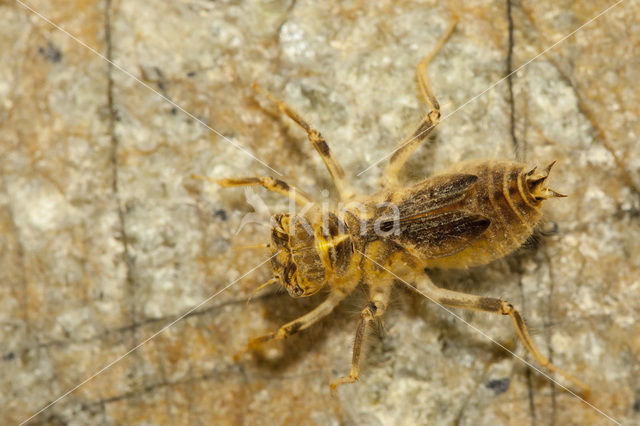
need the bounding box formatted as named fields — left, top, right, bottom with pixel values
left=271, top=214, right=325, bottom=297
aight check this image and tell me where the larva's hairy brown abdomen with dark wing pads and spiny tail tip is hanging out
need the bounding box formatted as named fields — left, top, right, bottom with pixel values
left=394, top=161, right=562, bottom=268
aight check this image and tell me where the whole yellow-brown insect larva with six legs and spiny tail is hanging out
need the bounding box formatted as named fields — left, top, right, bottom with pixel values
left=217, top=21, right=589, bottom=394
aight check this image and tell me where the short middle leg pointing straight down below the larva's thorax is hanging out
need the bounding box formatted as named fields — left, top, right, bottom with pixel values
left=330, top=280, right=392, bottom=394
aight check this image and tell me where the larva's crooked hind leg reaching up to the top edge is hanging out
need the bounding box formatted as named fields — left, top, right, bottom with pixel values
left=380, top=19, right=458, bottom=188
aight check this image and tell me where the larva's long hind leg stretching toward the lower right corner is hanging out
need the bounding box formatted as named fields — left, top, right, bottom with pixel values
left=415, top=275, right=590, bottom=398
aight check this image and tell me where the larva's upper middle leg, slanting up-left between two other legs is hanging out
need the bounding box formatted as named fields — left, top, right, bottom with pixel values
left=254, top=84, right=355, bottom=200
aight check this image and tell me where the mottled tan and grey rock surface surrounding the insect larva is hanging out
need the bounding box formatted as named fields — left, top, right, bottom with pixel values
left=0, top=0, right=640, bottom=425
